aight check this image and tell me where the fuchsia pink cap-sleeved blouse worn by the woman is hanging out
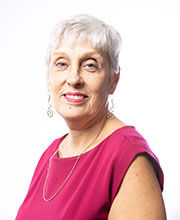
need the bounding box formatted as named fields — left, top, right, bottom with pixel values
left=16, top=126, right=163, bottom=220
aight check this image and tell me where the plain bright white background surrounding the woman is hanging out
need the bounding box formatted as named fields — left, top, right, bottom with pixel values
left=0, top=0, right=180, bottom=220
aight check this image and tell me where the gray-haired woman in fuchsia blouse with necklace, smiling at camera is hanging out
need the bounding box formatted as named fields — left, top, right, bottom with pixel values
left=16, top=15, right=166, bottom=220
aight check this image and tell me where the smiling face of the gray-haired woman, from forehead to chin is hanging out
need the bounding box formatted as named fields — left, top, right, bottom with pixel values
left=48, top=35, right=119, bottom=120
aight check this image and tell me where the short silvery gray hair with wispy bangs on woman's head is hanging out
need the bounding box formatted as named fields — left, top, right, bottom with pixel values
left=46, top=14, right=121, bottom=76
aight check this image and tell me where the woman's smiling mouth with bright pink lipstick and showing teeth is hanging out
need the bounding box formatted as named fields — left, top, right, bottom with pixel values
left=64, top=92, right=88, bottom=103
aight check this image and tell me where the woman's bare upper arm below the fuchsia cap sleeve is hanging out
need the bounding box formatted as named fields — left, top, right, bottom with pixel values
left=108, top=155, right=166, bottom=220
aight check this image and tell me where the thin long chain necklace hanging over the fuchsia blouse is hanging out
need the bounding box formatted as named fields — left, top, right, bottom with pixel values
left=43, top=117, right=106, bottom=202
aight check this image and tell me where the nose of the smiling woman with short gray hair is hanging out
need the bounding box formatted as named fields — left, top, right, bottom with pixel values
left=66, top=68, right=83, bottom=88
